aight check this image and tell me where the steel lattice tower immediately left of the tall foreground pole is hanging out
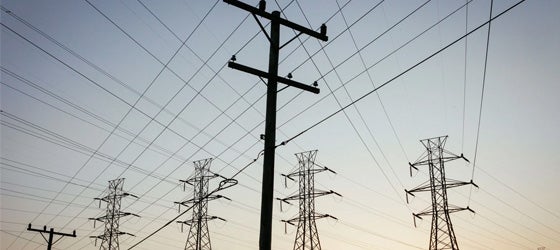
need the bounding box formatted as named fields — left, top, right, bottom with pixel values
left=175, top=158, right=229, bottom=250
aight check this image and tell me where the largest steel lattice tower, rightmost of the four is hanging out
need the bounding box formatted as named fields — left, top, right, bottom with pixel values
left=405, top=136, right=478, bottom=250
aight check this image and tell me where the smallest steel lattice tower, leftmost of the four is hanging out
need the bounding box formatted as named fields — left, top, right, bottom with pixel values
left=89, top=178, right=139, bottom=250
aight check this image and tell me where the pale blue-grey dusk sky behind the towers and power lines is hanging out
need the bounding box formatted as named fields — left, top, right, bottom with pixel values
left=0, top=0, right=560, bottom=250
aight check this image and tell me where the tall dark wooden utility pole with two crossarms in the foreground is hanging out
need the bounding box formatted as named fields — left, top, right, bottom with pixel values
left=224, top=0, right=328, bottom=250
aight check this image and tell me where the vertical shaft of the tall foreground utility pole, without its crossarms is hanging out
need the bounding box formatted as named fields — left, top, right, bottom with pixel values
left=259, top=11, right=280, bottom=250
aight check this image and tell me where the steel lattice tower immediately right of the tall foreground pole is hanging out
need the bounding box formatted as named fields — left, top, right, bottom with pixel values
left=278, top=150, right=341, bottom=250
